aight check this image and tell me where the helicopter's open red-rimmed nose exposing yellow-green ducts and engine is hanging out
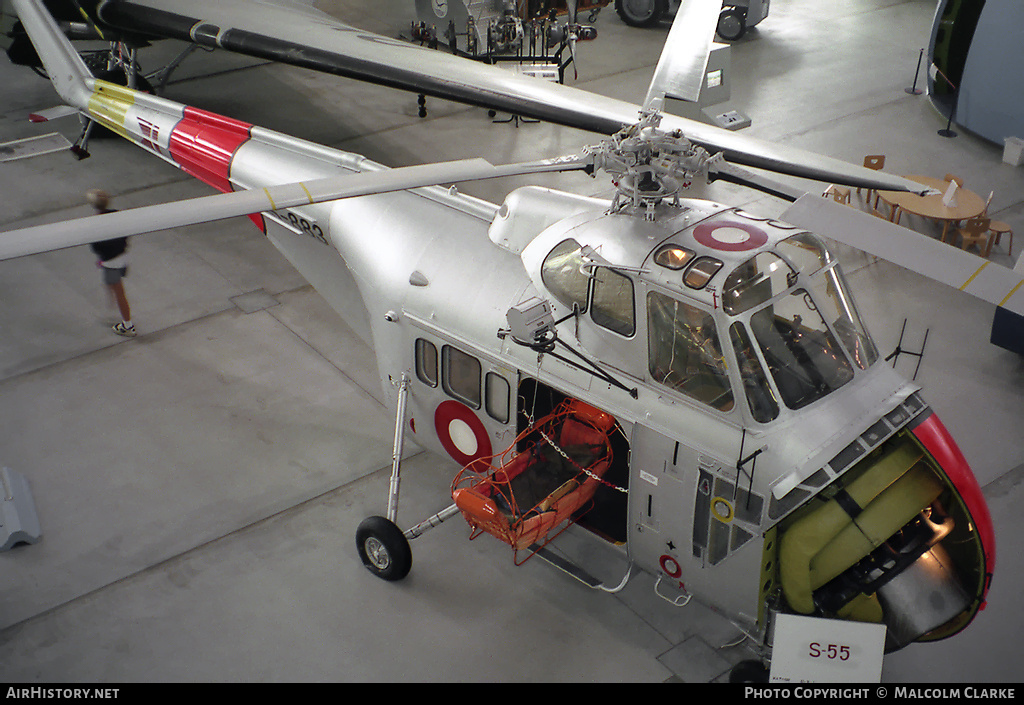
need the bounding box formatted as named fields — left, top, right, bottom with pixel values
left=777, top=409, right=995, bottom=651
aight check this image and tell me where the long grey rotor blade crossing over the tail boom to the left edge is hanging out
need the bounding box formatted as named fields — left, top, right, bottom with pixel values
left=0, top=155, right=592, bottom=260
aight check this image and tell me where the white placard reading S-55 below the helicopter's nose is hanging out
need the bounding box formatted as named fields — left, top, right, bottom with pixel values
left=771, top=615, right=886, bottom=682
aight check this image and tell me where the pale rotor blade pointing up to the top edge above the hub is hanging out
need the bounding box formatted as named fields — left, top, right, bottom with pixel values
left=643, top=0, right=722, bottom=111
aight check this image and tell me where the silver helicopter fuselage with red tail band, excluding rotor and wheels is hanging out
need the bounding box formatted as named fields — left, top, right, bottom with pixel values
left=9, top=0, right=994, bottom=646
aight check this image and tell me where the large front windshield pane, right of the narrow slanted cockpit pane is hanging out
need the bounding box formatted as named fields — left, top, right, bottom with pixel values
left=751, top=289, right=853, bottom=409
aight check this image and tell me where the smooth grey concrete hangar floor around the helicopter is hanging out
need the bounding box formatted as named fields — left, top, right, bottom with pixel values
left=0, top=0, right=1024, bottom=682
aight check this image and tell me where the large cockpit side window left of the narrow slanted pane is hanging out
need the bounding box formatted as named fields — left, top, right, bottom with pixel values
left=647, top=291, right=733, bottom=411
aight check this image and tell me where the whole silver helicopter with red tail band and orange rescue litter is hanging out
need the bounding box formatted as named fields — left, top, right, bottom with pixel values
left=0, top=0, right=1007, bottom=680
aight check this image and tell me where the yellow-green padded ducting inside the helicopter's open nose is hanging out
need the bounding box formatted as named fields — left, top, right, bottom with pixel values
left=778, top=441, right=941, bottom=614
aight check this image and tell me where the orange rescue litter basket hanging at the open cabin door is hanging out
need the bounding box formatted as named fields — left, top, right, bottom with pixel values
left=452, top=399, right=615, bottom=566
